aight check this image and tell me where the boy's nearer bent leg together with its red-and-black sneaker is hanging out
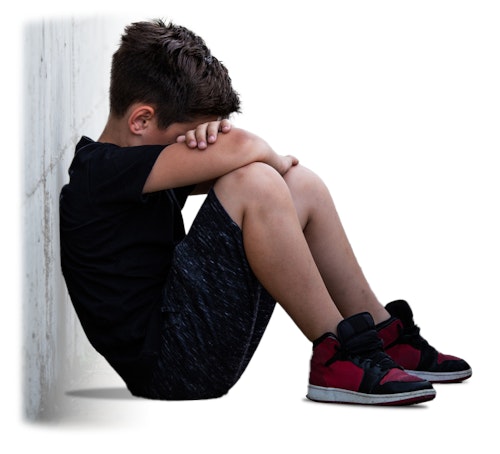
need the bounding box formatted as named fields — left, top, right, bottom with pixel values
left=214, top=163, right=435, bottom=405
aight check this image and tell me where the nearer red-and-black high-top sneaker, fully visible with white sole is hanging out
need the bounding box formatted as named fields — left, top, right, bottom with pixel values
left=307, top=312, right=436, bottom=405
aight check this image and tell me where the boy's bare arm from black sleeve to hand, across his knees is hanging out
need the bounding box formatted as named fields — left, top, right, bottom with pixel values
left=143, top=128, right=298, bottom=193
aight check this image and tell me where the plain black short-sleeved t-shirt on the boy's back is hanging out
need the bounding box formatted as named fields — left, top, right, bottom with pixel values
left=60, top=137, right=193, bottom=388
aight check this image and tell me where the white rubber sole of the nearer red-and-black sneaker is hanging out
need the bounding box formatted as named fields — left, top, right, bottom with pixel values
left=306, top=385, right=436, bottom=405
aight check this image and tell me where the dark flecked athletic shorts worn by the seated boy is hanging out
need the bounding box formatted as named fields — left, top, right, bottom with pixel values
left=139, top=190, right=275, bottom=400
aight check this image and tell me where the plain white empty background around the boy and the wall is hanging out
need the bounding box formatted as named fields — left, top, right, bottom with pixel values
left=0, top=0, right=500, bottom=452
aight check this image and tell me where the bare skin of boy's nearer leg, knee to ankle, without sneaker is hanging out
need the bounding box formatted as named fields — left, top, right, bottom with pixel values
left=214, top=163, right=342, bottom=341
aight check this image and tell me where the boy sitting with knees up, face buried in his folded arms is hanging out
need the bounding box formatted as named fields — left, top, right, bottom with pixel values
left=60, top=21, right=472, bottom=405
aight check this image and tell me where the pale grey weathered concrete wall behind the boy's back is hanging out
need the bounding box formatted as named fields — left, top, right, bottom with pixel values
left=22, top=18, right=123, bottom=420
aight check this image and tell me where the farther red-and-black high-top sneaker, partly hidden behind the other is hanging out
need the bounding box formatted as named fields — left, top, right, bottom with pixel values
left=377, top=300, right=472, bottom=383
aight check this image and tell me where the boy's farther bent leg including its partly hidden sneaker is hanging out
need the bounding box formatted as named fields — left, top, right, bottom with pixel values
left=285, top=163, right=472, bottom=382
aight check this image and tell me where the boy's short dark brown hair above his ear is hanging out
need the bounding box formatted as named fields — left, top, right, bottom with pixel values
left=110, top=20, right=240, bottom=129
